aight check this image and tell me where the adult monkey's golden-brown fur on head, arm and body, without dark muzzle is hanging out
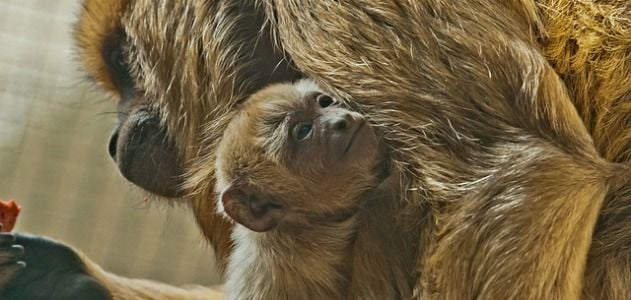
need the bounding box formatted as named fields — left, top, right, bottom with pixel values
left=6, top=0, right=631, bottom=299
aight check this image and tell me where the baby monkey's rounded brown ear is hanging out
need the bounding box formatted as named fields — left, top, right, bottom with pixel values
left=221, top=184, right=284, bottom=232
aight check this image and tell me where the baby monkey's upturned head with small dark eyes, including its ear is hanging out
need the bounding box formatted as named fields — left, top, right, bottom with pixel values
left=216, top=80, right=381, bottom=232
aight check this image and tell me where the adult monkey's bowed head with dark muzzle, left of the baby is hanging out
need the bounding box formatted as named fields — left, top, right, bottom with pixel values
left=76, top=0, right=297, bottom=262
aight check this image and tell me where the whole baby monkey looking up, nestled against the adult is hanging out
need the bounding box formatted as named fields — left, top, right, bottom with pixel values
left=216, top=80, right=414, bottom=300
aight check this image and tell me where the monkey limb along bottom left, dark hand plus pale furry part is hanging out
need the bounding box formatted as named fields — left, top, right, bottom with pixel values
left=0, top=233, right=223, bottom=300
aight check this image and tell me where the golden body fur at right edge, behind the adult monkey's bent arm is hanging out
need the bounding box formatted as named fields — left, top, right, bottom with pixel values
left=541, top=1, right=631, bottom=299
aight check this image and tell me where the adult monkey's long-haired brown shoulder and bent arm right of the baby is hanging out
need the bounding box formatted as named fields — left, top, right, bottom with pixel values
left=260, top=1, right=622, bottom=299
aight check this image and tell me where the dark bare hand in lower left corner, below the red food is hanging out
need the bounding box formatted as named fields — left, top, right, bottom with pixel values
left=0, top=233, right=111, bottom=300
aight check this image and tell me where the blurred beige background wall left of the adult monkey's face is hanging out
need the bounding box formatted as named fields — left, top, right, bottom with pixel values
left=0, top=0, right=222, bottom=284
